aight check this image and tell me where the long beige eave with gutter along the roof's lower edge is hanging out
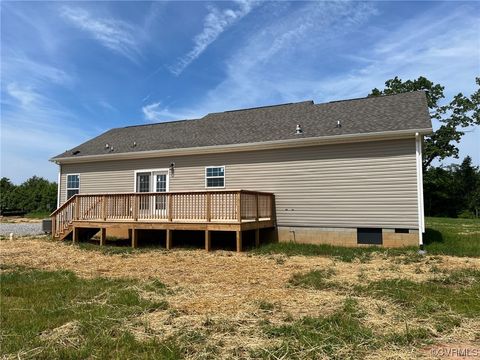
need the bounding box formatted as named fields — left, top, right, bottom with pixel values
left=50, top=128, right=433, bottom=164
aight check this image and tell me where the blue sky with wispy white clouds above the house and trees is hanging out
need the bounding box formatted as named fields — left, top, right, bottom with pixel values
left=0, top=1, right=480, bottom=183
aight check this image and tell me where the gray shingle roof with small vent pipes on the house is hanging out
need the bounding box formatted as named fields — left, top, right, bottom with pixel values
left=52, top=91, right=432, bottom=160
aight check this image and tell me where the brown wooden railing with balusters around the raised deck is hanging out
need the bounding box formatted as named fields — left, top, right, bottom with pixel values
left=51, top=190, right=275, bottom=237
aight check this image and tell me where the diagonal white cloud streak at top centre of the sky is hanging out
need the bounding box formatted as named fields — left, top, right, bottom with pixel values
left=169, top=0, right=255, bottom=75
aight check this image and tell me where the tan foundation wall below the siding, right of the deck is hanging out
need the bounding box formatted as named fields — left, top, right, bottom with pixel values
left=277, top=227, right=419, bottom=248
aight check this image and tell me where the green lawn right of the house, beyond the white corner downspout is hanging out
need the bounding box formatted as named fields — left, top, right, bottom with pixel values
left=424, top=218, right=480, bottom=257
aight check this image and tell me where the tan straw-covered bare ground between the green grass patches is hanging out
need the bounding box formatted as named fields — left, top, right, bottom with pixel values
left=0, top=239, right=480, bottom=359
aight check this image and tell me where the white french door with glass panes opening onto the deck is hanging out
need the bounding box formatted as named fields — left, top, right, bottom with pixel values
left=135, top=170, right=168, bottom=218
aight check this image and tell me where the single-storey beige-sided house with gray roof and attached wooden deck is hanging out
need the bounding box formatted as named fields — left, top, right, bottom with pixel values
left=51, top=91, right=432, bottom=250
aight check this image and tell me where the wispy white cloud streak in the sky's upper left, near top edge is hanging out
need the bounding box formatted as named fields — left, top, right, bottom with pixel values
left=61, top=6, right=140, bottom=62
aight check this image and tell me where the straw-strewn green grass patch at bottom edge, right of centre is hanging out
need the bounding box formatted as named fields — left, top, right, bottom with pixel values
left=252, top=298, right=432, bottom=359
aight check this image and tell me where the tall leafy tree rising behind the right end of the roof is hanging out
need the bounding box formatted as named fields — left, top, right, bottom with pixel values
left=368, top=76, right=480, bottom=171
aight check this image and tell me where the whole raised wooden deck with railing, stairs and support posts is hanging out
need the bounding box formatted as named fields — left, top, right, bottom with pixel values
left=51, top=190, right=276, bottom=251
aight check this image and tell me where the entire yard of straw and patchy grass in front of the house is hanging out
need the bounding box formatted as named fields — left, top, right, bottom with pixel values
left=0, top=229, right=480, bottom=359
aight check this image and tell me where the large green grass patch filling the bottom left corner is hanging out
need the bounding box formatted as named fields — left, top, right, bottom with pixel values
left=0, top=267, right=182, bottom=359
